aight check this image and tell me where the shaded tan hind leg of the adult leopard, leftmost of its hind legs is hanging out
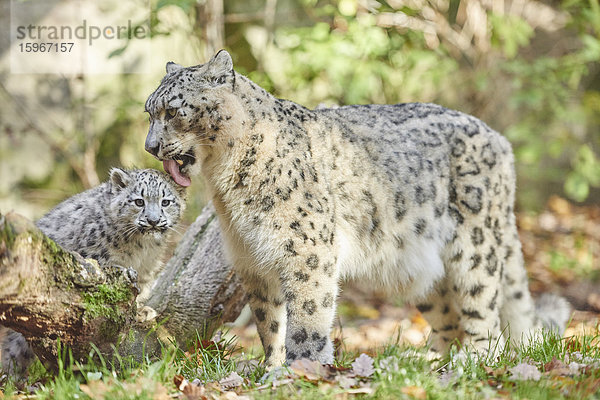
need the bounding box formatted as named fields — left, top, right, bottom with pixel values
left=417, top=278, right=462, bottom=354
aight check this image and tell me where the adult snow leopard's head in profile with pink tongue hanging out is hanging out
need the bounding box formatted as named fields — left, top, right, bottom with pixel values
left=145, top=50, right=235, bottom=186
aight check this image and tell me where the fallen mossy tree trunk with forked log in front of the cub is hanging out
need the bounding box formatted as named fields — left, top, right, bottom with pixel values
left=0, top=206, right=246, bottom=367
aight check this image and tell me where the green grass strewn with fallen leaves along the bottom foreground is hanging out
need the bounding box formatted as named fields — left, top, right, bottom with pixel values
left=0, top=334, right=600, bottom=400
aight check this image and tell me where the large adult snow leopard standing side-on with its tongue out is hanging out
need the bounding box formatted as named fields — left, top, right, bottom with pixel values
left=145, top=50, right=570, bottom=367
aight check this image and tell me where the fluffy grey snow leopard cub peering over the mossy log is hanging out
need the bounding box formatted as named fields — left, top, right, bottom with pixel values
left=0, top=168, right=185, bottom=374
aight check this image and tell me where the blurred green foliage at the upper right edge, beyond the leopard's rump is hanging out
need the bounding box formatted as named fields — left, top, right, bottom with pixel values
left=502, top=0, right=600, bottom=201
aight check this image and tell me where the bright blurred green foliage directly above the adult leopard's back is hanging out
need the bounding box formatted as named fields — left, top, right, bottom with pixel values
left=264, top=15, right=457, bottom=106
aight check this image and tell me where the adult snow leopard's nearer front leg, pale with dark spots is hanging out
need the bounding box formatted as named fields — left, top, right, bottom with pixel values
left=281, top=249, right=339, bottom=364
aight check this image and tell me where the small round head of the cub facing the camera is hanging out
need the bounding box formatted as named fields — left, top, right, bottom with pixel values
left=110, top=168, right=185, bottom=239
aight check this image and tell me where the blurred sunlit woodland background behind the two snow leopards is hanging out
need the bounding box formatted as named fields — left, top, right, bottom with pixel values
left=0, top=0, right=600, bottom=348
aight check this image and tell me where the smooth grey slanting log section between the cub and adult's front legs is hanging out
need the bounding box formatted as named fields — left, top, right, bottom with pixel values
left=145, top=204, right=247, bottom=344
